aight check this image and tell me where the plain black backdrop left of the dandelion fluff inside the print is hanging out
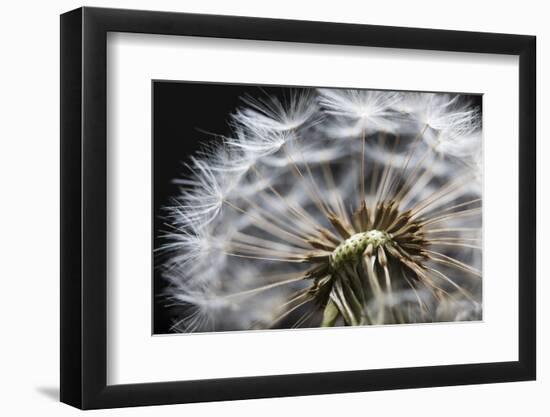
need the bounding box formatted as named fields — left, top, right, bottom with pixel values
left=152, top=80, right=308, bottom=334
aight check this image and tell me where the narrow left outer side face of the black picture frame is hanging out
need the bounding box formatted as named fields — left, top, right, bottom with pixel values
left=60, top=8, right=83, bottom=408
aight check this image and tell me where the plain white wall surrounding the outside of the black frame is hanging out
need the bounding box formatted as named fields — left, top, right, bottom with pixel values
left=0, top=0, right=550, bottom=417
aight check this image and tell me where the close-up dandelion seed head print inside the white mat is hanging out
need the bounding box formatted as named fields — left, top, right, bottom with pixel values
left=153, top=81, right=483, bottom=334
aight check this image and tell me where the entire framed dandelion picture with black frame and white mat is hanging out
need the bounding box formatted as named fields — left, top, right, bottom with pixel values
left=61, top=7, right=536, bottom=409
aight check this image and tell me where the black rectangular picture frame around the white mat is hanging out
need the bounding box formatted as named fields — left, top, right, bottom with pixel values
left=60, top=7, right=536, bottom=409
